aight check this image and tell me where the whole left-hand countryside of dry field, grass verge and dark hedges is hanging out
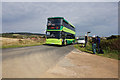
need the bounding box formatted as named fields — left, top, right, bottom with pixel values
left=0, top=33, right=45, bottom=48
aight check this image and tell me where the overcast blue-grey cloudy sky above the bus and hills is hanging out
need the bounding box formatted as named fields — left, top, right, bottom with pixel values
left=2, top=2, right=118, bottom=37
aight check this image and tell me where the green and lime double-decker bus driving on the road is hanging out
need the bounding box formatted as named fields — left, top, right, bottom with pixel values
left=46, top=17, right=75, bottom=45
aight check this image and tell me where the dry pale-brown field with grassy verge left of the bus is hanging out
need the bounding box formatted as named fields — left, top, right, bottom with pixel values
left=0, top=37, right=45, bottom=48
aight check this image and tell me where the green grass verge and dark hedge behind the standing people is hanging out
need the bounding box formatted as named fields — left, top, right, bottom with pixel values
left=74, top=36, right=120, bottom=60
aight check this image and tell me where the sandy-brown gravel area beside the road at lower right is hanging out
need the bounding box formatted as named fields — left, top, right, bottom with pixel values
left=41, top=49, right=118, bottom=78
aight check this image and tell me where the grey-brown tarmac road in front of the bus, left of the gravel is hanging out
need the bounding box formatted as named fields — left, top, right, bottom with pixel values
left=2, top=45, right=74, bottom=78
